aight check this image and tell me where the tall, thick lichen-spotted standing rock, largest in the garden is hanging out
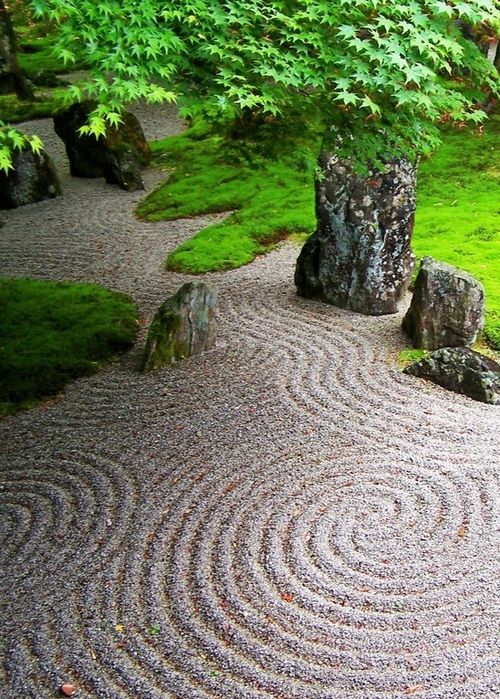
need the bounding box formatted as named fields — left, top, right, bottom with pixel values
left=295, top=152, right=416, bottom=315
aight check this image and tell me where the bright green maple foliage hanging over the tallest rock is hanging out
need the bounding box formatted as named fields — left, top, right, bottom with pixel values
left=32, top=0, right=499, bottom=159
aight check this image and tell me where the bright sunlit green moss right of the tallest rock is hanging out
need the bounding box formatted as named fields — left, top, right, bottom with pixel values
left=413, top=117, right=500, bottom=349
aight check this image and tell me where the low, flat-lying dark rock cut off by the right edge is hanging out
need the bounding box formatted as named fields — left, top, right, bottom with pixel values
left=404, top=347, right=500, bottom=405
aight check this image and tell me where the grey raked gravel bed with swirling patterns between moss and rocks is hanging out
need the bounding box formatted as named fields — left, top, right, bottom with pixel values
left=0, top=110, right=500, bottom=699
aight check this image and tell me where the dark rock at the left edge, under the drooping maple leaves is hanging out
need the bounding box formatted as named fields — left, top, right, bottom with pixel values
left=0, top=147, right=61, bottom=209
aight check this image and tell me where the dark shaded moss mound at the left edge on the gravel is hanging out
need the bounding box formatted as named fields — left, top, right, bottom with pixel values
left=0, top=279, right=137, bottom=415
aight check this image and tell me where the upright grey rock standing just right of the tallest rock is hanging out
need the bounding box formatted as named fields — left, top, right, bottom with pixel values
left=403, top=257, right=484, bottom=350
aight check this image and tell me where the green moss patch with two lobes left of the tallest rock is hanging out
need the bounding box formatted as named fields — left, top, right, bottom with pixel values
left=137, top=111, right=320, bottom=274
